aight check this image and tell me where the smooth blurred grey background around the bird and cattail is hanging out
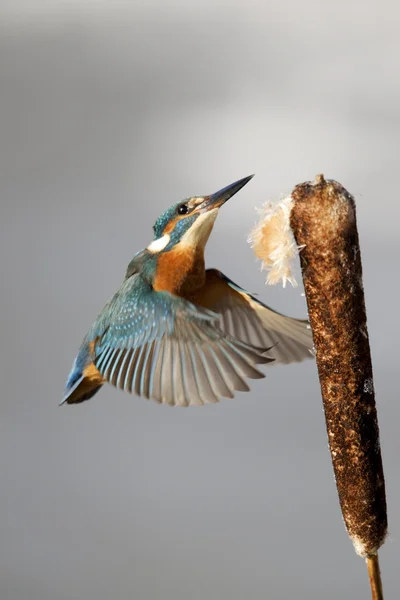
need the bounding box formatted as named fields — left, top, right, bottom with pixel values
left=0, top=0, right=400, bottom=600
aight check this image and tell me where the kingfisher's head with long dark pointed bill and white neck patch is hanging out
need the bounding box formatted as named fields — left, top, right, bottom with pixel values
left=147, top=175, right=253, bottom=255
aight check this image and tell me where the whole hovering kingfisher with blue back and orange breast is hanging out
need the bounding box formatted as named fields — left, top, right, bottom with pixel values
left=61, top=175, right=312, bottom=406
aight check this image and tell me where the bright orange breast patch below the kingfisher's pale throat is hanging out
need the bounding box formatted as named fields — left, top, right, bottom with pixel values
left=153, top=245, right=206, bottom=296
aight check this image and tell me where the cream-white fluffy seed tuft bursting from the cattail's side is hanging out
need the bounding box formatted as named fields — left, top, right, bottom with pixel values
left=249, top=196, right=301, bottom=287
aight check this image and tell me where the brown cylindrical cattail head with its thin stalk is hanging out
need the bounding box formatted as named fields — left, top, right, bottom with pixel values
left=290, top=175, right=387, bottom=598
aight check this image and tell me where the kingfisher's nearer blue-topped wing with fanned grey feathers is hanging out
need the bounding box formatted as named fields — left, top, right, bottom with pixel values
left=86, top=274, right=272, bottom=406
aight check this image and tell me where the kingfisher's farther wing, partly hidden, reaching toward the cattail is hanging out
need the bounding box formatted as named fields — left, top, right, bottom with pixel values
left=189, top=269, right=313, bottom=364
